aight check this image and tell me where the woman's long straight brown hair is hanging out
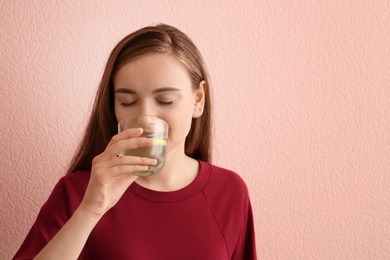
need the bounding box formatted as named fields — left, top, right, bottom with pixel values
left=67, top=24, right=212, bottom=173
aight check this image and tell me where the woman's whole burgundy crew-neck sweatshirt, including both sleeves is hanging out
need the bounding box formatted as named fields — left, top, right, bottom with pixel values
left=14, top=161, right=257, bottom=260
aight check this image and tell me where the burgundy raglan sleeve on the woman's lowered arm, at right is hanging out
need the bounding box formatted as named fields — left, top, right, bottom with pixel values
left=204, top=166, right=257, bottom=260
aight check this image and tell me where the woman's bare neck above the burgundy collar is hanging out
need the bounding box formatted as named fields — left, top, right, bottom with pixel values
left=136, top=147, right=199, bottom=191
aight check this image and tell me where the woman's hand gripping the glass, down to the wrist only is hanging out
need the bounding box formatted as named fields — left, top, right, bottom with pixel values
left=79, top=128, right=157, bottom=218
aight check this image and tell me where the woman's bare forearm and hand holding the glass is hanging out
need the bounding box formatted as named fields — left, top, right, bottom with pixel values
left=34, top=128, right=157, bottom=259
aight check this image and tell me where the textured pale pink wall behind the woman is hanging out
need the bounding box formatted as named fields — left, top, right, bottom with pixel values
left=0, top=0, right=390, bottom=259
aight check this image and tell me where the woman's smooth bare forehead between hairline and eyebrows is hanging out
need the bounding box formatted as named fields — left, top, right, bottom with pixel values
left=114, top=53, right=191, bottom=89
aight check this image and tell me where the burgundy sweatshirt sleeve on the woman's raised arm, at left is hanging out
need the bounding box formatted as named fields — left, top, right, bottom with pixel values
left=13, top=179, right=70, bottom=259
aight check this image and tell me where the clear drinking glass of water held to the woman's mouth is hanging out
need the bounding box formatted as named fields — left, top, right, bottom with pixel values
left=118, top=115, right=168, bottom=176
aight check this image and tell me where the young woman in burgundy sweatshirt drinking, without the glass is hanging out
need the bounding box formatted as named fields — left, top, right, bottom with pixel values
left=14, top=24, right=256, bottom=260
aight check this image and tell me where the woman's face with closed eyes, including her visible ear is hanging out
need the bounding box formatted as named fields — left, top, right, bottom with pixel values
left=114, top=53, right=204, bottom=152
